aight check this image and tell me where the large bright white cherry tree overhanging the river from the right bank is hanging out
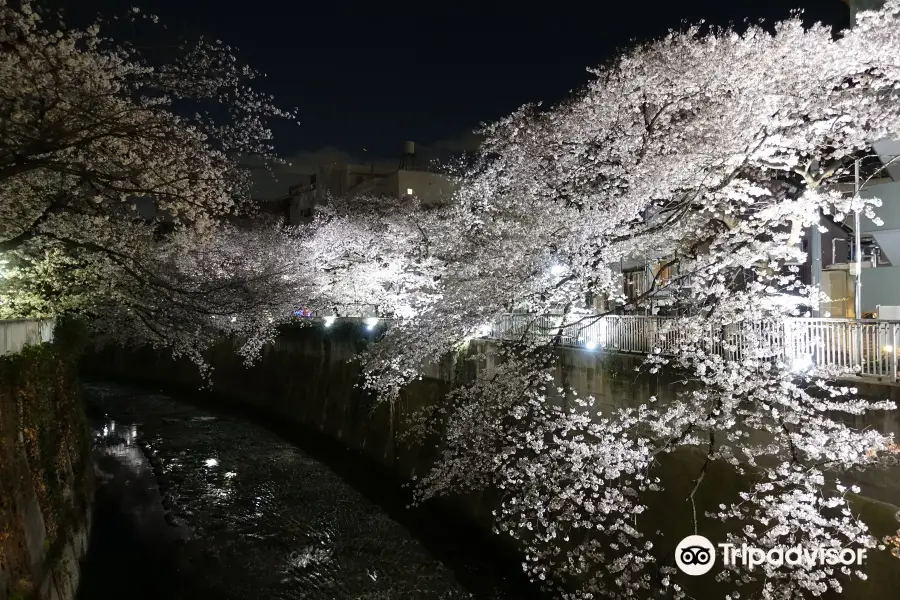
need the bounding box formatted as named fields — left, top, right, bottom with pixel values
left=348, top=0, right=900, bottom=599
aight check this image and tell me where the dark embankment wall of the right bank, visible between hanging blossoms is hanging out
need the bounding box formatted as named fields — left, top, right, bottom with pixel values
left=85, top=324, right=900, bottom=599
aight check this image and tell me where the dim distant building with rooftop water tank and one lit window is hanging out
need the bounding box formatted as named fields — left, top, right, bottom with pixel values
left=283, top=142, right=458, bottom=225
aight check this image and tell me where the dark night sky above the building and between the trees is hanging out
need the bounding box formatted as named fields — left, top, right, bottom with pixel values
left=49, top=0, right=848, bottom=166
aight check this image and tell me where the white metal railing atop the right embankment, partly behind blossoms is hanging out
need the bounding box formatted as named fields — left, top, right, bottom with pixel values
left=485, top=314, right=900, bottom=382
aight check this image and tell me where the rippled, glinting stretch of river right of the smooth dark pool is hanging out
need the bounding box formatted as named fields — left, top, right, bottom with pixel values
left=86, top=386, right=471, bottom=600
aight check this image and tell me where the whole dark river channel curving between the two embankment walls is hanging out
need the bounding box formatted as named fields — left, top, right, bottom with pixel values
left=79, top=384, right=508, bottom=600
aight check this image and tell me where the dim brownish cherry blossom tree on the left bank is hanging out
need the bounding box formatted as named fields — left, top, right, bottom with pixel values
left=0, top=0, right=297, bottom=357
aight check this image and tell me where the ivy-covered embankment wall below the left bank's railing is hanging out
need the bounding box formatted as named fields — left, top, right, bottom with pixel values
left=0, top=328, right=93, bottom=600
